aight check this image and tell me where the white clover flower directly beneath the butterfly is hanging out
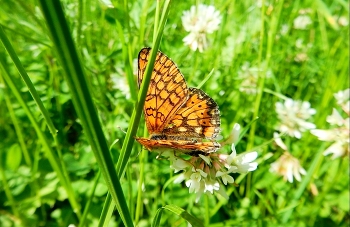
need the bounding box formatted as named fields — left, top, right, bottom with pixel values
left=169, top=144, right=258, bottom=201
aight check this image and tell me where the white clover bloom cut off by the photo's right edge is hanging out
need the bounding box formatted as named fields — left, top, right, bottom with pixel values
left=311, top=92, right=350, bottom=159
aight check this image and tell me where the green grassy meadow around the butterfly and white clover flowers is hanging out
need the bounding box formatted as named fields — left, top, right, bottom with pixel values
left=0, top=0, right=350, bottom=227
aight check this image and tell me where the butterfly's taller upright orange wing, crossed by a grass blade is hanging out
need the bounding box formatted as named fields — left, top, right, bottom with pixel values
left=138, top=48, right=188, bottom=134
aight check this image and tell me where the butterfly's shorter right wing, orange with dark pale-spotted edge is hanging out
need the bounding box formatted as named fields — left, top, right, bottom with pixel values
left=163, top=88, right=220, bottom=140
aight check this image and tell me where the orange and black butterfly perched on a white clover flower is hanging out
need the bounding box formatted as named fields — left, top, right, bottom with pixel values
left=136, top=48, right=220, bottom=156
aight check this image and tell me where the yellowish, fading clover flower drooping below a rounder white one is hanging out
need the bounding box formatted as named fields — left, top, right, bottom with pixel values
left=270, top=151, right=306, bottom=183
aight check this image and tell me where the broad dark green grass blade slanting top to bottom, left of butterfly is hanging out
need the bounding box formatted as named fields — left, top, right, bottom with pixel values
left=40, top=0, right=133, bottom=226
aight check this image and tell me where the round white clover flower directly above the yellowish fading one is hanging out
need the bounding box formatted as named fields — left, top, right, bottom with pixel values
left=276, top=98, right=316, bottom=139
